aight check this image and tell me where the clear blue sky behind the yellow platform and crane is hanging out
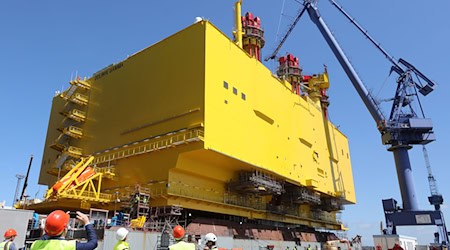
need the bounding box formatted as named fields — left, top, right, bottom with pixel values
left=0, top=0, right=450, bottom=245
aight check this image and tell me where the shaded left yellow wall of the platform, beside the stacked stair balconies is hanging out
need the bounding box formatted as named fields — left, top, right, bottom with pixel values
left=83, top=24, right=205, bottom=153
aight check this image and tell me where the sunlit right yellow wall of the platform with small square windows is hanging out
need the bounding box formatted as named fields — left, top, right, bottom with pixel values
left=205, top=22, right=355, bottom=202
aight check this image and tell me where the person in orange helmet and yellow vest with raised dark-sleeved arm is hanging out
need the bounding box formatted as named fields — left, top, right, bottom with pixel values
left=30, top=210, right=97, bottom=250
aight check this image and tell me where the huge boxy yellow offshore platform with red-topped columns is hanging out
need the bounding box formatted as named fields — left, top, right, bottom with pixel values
left=31, top=2, right=355, bottom=232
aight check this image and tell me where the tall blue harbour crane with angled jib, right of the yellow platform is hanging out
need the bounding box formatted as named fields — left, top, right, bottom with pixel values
left=266, top=0, right=448, bottom=245
